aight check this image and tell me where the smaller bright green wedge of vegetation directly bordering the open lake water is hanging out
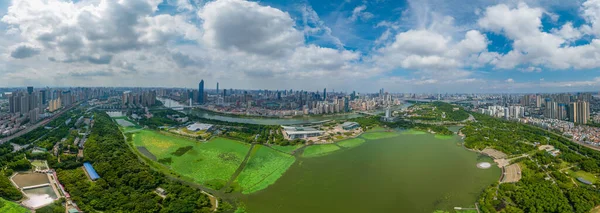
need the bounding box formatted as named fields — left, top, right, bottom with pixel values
left=236, top=145, right=296, bottom=194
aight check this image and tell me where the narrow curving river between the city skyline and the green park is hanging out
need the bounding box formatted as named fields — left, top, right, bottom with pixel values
left=158, top=98, right=410, bottom=125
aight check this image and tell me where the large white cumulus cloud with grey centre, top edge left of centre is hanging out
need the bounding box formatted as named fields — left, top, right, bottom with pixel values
left=198, top=0, right=304, bottom=56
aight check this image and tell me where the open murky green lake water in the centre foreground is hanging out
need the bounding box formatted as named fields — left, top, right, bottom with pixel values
left=240, top=134, right=501, bottom=213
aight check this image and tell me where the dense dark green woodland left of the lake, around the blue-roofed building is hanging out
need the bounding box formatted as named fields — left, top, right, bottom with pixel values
left=58, top=113, right=216, bottom=212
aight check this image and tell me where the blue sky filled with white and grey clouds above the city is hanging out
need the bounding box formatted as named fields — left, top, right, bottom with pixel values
left=0, top=0, right=600, bottom=93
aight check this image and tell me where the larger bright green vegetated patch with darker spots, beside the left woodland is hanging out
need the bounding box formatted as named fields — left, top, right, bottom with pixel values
left=133, top=130, right=250, bottom=184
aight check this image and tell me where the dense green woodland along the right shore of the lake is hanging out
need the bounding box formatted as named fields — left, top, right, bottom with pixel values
left=461, top=114, right=600, bottom=213
